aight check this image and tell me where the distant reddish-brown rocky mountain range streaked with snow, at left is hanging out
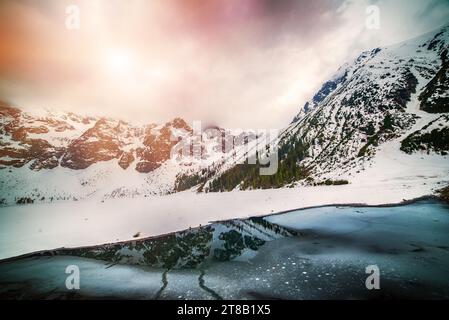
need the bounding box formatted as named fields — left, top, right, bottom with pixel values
left=0, top=103, right=260, bottom=205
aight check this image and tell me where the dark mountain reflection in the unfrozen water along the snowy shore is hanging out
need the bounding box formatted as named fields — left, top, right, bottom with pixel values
left=51, top=218, right=297, bottom=269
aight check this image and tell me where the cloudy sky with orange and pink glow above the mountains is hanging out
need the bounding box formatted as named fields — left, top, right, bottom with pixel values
left=0, top=0, right=449, bottom=128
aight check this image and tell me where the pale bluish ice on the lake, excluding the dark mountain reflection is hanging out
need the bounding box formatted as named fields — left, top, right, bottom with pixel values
left=0, top=201, right=449, bottom=299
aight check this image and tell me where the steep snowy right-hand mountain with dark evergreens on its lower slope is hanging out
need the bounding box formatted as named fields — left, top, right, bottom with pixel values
left=205, top=26, right=449, bottom=191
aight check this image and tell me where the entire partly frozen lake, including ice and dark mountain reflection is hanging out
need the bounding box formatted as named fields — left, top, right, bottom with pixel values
left=0, top=201, right=449, bottom=299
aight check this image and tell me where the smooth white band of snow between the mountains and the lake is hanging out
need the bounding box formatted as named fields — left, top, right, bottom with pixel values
left=0, top=172, right=447, bottom=259
